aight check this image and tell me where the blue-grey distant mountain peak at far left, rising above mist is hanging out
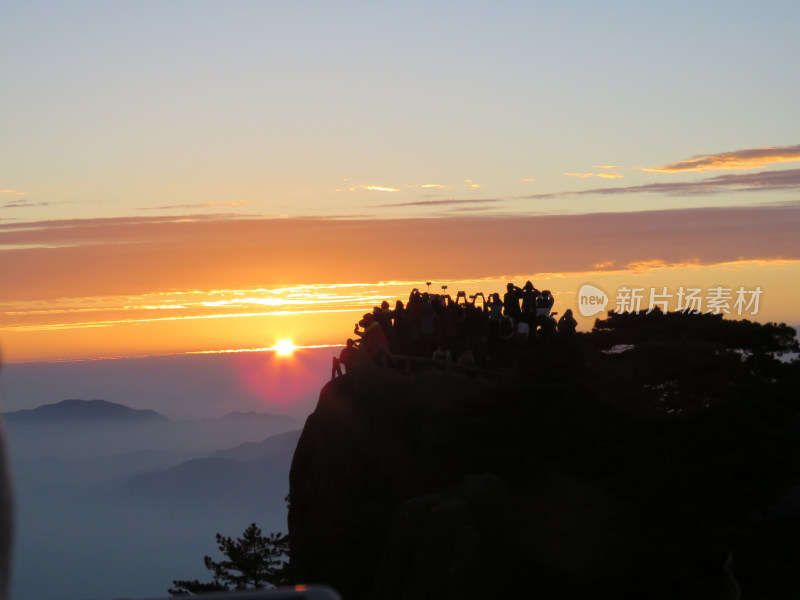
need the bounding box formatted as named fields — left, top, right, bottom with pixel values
left=3, top=399, right=170, bottom=423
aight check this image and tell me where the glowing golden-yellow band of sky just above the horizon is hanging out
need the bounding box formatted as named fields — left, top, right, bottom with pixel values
left=0, top=259, right=800, bottom=362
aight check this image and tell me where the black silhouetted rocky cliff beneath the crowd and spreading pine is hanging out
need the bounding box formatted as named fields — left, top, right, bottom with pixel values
left=289, top=316, right=800, bottom=600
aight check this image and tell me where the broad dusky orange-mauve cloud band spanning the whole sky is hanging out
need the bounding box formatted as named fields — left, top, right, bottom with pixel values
left=0, top=203, right=800, bottom=310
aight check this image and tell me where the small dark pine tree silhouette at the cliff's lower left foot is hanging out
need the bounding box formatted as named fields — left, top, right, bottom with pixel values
left=167, top=523, right=289, bottom=596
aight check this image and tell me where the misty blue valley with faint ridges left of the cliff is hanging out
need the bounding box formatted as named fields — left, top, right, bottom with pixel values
left=4, top=400, right=301, bottom=600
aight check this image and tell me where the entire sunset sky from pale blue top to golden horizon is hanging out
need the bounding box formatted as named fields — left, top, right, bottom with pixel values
left=0, top=0, right=800, bottom=363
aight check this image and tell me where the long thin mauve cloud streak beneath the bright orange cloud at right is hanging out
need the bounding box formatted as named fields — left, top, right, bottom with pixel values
left=526, top=169, right=800, bottom=199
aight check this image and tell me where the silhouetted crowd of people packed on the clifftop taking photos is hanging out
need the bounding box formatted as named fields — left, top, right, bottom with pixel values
left=331, top=281, right=578, bottom=377
